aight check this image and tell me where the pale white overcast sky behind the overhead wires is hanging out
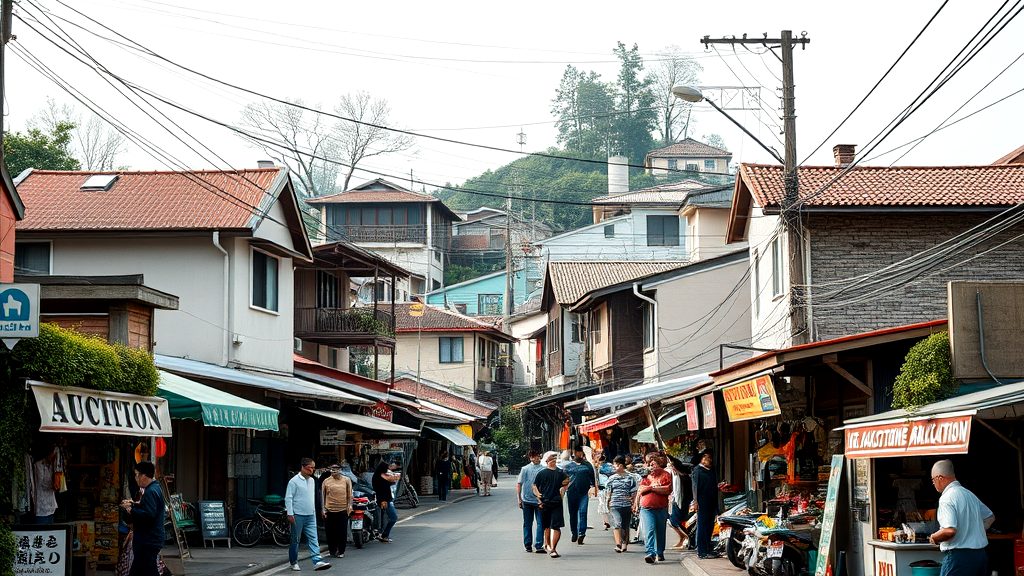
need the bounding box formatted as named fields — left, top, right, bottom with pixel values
left=5, top=0, right=1024, bottom=198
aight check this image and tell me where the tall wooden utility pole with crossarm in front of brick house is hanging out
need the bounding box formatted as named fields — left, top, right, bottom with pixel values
left=700, top=30, right=811, bottom=345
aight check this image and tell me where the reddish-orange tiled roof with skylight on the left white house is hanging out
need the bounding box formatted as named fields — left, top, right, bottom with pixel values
left=17, top=168, right=287, bottom=231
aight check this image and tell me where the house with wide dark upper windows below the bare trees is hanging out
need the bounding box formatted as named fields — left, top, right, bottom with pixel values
left=306, top=178, right=460, bottom=294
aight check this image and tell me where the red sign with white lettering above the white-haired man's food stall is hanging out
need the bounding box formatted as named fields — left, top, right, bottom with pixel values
left=845, top=414, right=972, bottom=458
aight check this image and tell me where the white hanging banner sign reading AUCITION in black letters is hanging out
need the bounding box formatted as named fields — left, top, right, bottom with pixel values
left=30, top=382, right=171, bottom=437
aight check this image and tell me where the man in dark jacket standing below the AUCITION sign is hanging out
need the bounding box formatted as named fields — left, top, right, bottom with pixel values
left=121, top=460, right=167, bottom=576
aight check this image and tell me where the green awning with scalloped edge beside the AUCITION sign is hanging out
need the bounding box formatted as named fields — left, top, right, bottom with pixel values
left=157, top=370, right=278, bottom=431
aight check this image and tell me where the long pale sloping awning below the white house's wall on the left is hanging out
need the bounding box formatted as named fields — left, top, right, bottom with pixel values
left=153, top=354, right=376, bottom=406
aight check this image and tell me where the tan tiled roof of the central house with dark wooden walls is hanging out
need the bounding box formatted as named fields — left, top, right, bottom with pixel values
left=548, top=260, right=688, bottom=304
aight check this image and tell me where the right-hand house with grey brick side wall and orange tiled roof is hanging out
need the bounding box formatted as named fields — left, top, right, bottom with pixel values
left=728, top=145, right=1024, bottom=348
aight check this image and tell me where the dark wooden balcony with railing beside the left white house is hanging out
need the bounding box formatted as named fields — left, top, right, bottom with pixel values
left=295, top=307, right=394, bottom=345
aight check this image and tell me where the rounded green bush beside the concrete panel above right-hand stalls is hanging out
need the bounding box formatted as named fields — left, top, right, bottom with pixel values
left=892, top=332, right=958, bottom=411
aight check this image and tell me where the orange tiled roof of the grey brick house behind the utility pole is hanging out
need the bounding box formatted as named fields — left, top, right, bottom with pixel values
left=737, top=164, right=1024, bottom=207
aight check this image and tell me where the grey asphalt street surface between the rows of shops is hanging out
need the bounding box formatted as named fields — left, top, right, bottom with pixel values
left=251, top=476, right=687, bottom=576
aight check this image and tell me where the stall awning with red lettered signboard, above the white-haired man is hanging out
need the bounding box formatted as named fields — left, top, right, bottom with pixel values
left=837, top=381, right=1024, bottom=458
